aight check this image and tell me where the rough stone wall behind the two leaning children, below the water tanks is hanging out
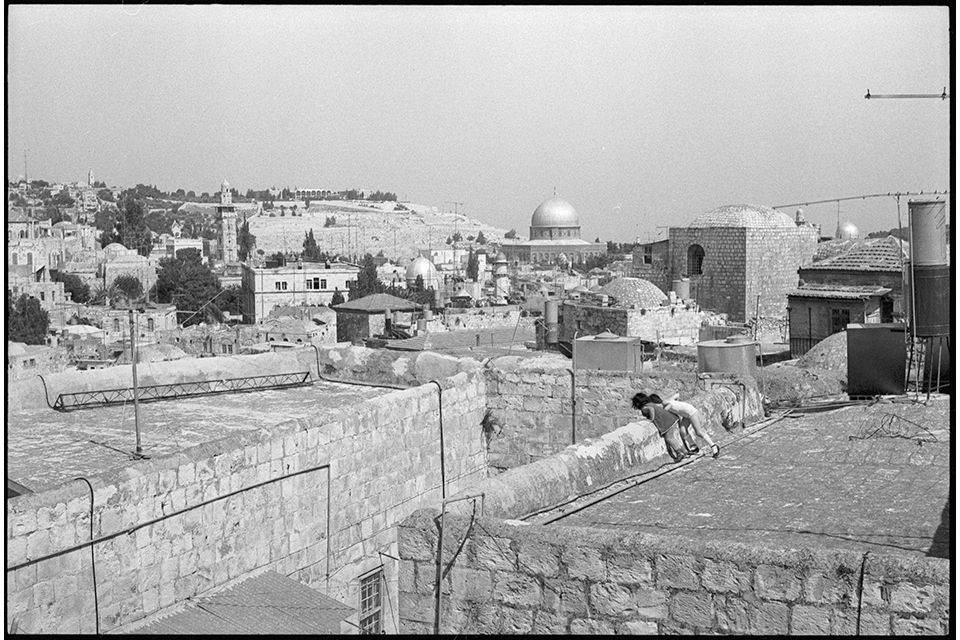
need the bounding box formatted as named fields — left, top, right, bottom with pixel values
left=484, top=357, right=763, bottom=471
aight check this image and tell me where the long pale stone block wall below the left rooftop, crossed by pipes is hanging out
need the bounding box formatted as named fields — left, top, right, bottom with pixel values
left=6, top=348, right=486, bottom=633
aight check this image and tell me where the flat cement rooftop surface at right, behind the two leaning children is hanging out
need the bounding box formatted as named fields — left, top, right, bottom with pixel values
left=552, top=396, right=952, bottom=557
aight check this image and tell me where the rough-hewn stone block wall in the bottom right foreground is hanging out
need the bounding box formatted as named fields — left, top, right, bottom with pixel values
left=399, top=509, right=950, bottom=635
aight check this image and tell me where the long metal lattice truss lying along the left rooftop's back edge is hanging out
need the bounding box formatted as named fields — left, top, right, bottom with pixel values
left=53, top=371, right=314, bottom=412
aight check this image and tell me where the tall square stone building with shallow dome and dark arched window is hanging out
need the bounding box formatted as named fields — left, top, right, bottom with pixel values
left=669, top=205, right=819, bottom=322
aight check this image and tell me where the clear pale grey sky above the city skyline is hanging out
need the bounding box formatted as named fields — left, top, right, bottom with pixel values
left=5, top=4, right=952, bottom=242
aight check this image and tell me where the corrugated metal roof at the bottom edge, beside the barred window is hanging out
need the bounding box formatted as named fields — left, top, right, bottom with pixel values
left=128, top=571, right=354, bottom=635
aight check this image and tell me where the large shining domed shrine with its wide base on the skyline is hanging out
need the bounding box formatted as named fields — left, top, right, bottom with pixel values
left=501, top=197, right=607, bottom=264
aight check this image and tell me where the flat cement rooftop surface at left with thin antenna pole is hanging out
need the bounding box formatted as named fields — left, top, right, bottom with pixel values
left=6, top=382, right=391, bottom=492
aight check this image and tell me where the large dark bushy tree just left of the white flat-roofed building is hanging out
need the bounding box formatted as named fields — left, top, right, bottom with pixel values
left=153, top=249, right=220, bottom=326
